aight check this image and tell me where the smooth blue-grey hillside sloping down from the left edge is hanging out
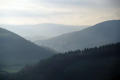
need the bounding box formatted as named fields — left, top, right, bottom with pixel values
left=0, top=28, right=54, bottom=69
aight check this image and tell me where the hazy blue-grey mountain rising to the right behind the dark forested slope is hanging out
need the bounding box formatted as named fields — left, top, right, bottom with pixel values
left=36, top=20, right=120, bottom=52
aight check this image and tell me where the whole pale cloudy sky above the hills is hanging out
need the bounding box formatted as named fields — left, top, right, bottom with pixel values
left=0, top=0, right=120, bottom=25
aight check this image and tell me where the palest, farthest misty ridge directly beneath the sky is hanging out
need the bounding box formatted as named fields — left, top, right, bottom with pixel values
left=1, top=23, right=88, bottom=42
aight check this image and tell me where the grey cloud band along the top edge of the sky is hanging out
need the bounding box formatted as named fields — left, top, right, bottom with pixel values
left=31, top=0, right=120, bottom=8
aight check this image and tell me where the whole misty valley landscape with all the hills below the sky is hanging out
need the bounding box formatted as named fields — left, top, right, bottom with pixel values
left=0, top=20, right=120, bottom=80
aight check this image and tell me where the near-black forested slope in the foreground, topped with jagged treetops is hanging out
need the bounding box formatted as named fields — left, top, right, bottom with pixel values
left=11, top=43, right=120, bottom=80
